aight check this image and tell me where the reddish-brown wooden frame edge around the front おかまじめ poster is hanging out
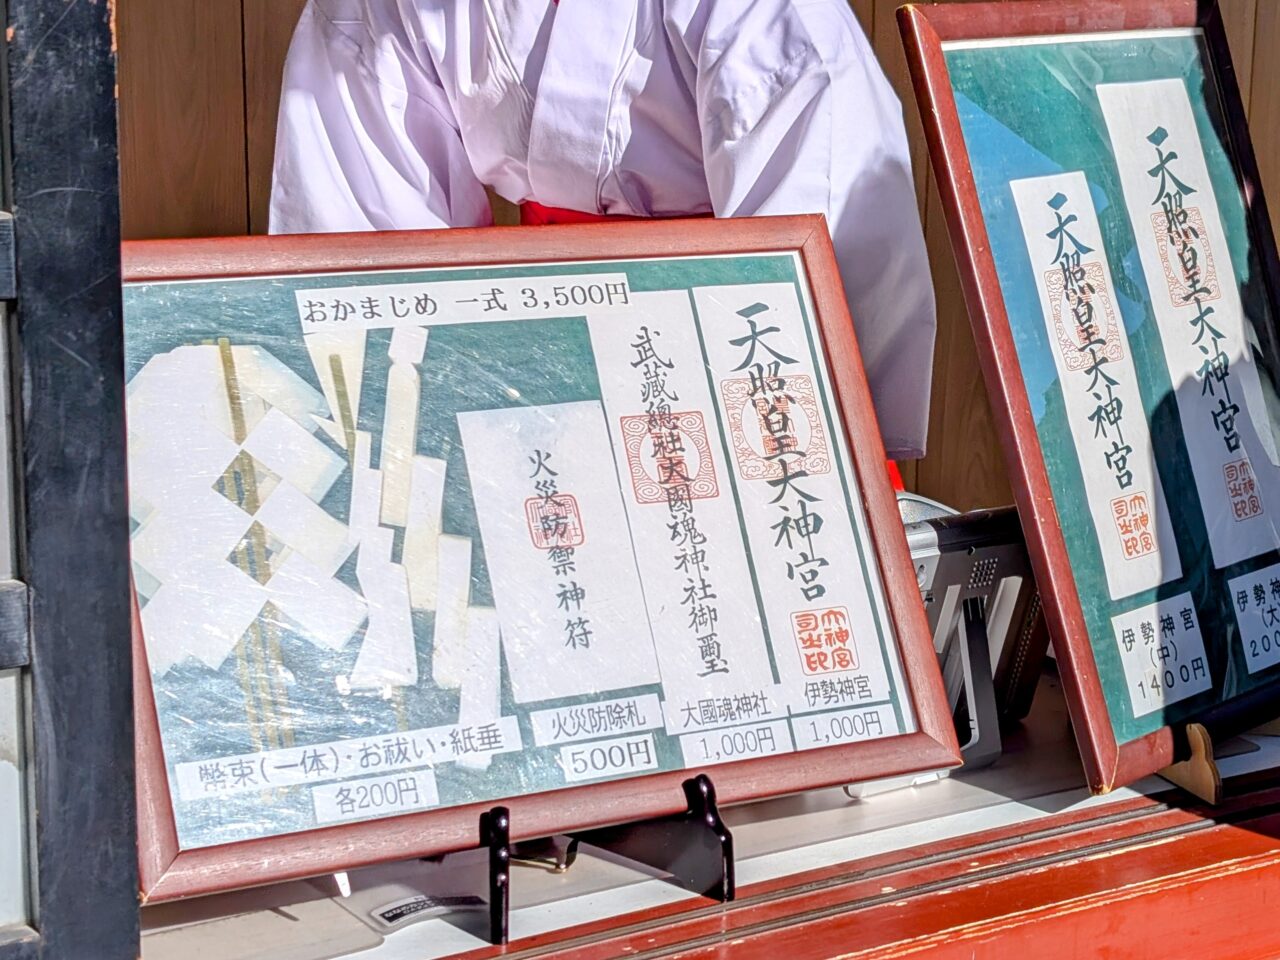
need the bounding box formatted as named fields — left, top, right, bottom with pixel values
left=122, top=216, right=960, bottom=902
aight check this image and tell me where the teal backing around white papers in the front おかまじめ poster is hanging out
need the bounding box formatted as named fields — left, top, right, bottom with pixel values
left=124, top=255, right=901, bottom=849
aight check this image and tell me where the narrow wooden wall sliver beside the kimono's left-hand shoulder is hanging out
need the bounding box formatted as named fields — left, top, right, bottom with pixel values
left=243, top=0, right=306, bottom=233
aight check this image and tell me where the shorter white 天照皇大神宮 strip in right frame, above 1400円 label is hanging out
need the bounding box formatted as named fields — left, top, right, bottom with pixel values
left=1009, top=173, right=1183, bottom=600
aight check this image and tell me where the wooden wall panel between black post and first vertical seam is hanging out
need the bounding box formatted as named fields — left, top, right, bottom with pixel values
left=118, top=0, right=249, bottom=239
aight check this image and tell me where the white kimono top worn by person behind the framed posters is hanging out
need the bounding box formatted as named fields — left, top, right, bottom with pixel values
left=271, top=0, right=934, bottom=458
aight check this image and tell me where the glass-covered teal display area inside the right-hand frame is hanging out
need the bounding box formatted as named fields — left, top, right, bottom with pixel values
left=943, top=29, right=1280, bottom=742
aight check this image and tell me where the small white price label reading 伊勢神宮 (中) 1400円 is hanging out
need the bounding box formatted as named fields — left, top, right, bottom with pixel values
left=1111, top=594, right=1213, bottom=717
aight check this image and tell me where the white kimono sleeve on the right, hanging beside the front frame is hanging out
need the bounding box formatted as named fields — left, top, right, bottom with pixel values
left=677, top=0, right=936, bottom=460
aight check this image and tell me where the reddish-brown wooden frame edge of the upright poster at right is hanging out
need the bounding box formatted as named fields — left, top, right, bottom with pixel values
left=899, top=0, right=1276, bottom=792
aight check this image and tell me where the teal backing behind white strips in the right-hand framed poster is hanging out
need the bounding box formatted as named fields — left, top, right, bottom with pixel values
left=945, top=33, right=1277, bottom=742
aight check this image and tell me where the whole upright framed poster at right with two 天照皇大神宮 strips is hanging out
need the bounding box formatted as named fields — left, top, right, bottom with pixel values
left=899, top=0, right=1280, bottom=791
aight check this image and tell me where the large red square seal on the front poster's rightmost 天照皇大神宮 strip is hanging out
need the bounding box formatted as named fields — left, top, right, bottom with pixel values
left=721, top=374, right=831, bottom=480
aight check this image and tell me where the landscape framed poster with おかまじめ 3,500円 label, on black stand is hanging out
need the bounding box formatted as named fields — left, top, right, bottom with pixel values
left=124, top=216, right=960, bottom=900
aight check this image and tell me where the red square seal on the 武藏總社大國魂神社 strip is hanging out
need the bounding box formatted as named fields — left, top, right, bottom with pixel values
left=622, top=411, right=719, bottom=503
